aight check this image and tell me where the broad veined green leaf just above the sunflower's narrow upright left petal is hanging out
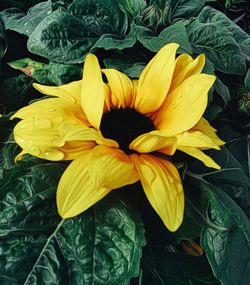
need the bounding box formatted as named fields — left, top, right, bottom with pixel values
left=27, top=6, right=127, bottom=64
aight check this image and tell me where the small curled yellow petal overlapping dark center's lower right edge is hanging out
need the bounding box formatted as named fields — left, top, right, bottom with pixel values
left=129, top=131, right=177, bottom=155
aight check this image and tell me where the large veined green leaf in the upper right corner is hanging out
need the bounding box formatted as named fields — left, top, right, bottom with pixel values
left=186, top=7, right=246, bottom=75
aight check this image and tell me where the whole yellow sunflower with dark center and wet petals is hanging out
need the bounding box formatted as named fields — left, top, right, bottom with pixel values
left=13, top=43, right=223, bottom=231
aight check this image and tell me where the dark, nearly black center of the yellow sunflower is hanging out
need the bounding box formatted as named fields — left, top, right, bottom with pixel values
left=101, top=108, right=155, bottom=154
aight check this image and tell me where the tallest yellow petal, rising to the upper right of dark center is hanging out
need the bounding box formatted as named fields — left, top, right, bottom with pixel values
left=135, top=43, right=179, bottom=114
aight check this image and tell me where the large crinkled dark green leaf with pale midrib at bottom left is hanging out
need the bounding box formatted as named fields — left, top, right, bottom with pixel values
left=0, top=163, right=145, bottom=285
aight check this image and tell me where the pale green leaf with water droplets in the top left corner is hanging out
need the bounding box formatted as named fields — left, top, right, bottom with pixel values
left=0, top=1, right=52, bottom=36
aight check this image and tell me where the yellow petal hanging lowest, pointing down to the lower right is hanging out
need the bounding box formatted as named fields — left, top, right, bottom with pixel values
left=131, top=154, right=184, bottom=232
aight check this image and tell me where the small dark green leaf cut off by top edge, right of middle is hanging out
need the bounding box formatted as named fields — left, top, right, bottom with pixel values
left=168, top=0, right=206, bottom=22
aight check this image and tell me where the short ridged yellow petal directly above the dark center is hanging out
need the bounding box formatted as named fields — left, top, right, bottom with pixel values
left=102, top=69, right=133, bottom=108
